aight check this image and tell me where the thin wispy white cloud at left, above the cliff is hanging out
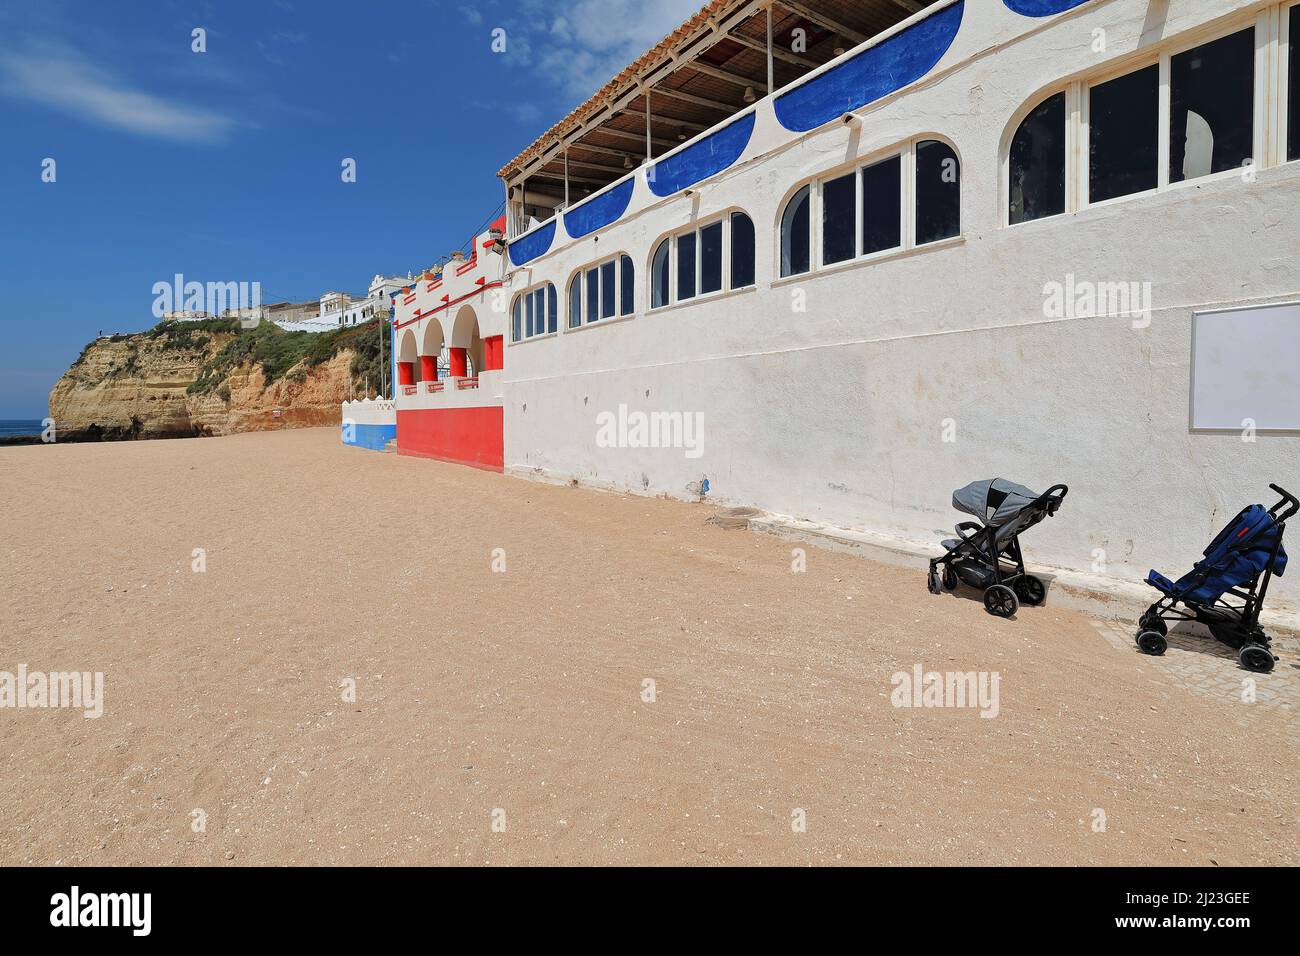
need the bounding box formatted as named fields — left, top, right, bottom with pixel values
left=0, top=47, right=235, bottom=143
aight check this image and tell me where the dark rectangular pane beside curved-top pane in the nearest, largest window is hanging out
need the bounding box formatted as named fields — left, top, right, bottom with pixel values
left=1088, top=64, right=1160, bottom=203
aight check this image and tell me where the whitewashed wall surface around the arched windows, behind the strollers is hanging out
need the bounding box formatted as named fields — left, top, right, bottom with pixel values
left=503, top=0, right=1300, bottom=604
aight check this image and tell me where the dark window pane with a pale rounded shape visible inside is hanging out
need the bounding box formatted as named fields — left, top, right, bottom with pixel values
left=1169, top=27, right=1255, bottom=182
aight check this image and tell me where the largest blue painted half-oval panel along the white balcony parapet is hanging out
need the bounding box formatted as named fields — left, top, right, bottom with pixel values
left=772, top=3, right=966, bottom=133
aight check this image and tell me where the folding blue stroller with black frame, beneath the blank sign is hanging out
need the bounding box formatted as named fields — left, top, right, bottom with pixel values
left=1138, top=485, right=1300, bottom=674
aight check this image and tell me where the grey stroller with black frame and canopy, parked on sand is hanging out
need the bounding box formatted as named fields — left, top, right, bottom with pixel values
left=927, top=479, right=1070, bottom=618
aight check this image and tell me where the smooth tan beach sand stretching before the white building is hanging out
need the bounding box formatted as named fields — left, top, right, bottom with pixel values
left=0, top=429, right=1300, bottom=865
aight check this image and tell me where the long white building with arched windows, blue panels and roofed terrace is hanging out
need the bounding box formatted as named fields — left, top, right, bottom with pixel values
left=384, top=0, right=1300, bottom=621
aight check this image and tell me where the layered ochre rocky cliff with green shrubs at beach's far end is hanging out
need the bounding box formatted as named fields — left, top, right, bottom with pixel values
left=49, top=321, right=378, bottom=441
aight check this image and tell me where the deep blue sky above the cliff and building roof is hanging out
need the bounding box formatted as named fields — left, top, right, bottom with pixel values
left=0, top=0, right=702, bottom=419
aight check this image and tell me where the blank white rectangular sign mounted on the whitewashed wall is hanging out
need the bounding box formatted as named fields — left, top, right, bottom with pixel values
left=1191, top=302, right=1300, bottom=431
